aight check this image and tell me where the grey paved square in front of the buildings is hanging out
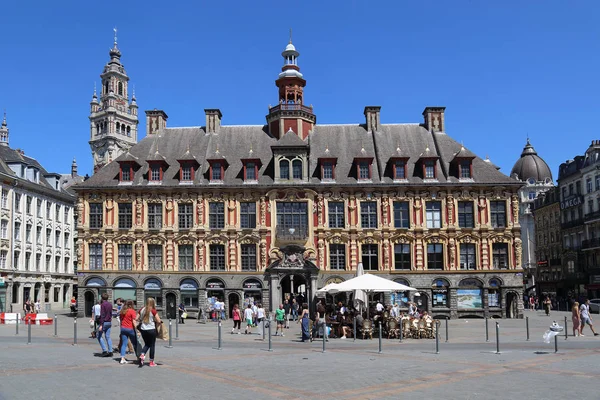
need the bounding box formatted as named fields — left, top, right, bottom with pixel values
left=0, top=311, right=600, bottom=400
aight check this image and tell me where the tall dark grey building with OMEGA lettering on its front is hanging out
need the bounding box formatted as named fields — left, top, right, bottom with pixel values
left=558, top=156, right=586, bottom=296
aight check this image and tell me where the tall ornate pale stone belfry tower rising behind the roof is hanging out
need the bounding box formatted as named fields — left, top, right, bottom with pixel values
left=89, top=29, right=139, bottom=172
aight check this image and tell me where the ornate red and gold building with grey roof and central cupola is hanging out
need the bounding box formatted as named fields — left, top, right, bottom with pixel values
left=77, top=39, right=523, bottom=318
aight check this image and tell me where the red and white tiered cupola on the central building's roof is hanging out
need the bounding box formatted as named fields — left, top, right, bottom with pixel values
left=267, top=31, right=317, bottom=140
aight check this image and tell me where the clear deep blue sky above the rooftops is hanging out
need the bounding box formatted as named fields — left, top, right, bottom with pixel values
left=0, top=0, right=600, bottom=179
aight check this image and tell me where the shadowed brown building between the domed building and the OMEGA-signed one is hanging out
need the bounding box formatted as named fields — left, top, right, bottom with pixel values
left=532, top=186, right=564, bottom=298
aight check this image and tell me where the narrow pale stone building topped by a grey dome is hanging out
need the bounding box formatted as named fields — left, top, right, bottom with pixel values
left=510, top=139, right=554, bottom=292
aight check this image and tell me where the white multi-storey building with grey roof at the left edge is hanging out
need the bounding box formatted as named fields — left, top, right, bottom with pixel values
left=0, top=115, right=77, bottom=312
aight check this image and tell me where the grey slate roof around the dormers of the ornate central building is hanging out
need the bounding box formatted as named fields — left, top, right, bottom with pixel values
left=76, top=124, right=520, bottom=189
